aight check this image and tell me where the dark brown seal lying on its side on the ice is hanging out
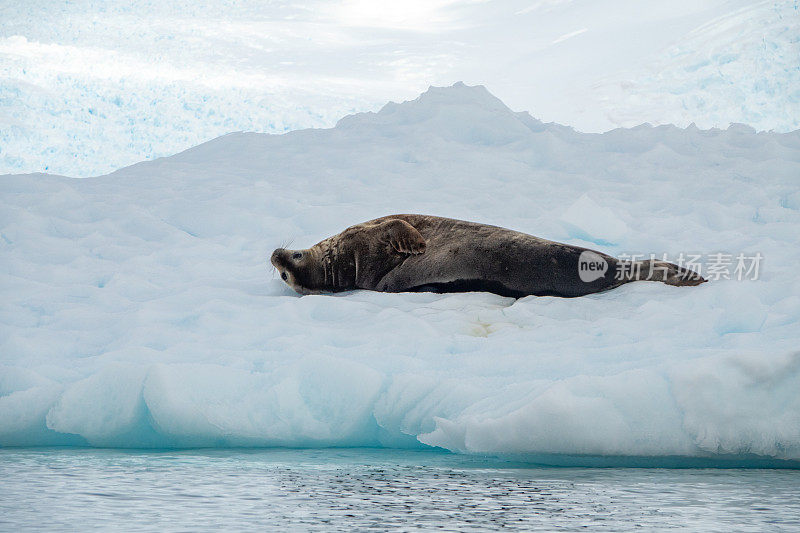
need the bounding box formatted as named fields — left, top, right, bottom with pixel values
left=270, top=215, right=706, bottom=298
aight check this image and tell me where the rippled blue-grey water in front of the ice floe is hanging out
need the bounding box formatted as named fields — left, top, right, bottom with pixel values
left=0, top=449, right=800, bottom=531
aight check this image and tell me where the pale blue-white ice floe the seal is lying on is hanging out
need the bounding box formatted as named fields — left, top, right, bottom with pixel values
left=0, top=84, right=800, bottom=461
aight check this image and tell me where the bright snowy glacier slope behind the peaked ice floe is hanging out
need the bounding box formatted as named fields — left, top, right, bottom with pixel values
left=0, top=0, right=800, bottom=177
